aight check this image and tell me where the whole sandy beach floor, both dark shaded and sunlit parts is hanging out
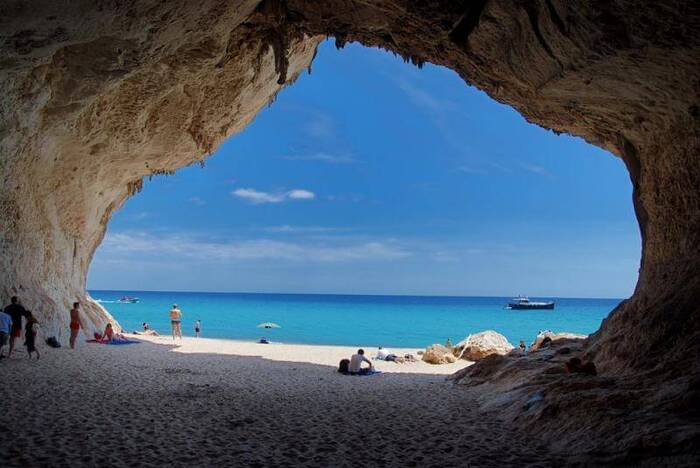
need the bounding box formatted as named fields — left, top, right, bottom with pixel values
left=0, top=337, right=551, bottom=467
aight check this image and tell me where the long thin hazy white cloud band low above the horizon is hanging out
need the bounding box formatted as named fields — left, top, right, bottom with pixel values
left=101, top=232, right=411, bottom=263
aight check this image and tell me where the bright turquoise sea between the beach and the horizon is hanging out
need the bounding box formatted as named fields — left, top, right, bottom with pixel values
left=90, top=291, right=620, bottom=347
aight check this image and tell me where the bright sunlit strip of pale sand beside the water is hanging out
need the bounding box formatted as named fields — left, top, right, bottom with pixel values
left=124, top=333, right=472, bottom=375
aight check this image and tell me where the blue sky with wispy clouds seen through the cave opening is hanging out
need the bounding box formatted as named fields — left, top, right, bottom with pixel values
left=88, top=42, right=640, bottom=298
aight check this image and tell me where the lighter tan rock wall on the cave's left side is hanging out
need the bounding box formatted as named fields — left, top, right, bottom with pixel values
left=0, top=1, right=320, bottom=340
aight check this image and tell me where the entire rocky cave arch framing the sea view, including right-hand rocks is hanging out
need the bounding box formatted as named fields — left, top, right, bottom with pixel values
left=0, top=0, right=700, bottom=465
